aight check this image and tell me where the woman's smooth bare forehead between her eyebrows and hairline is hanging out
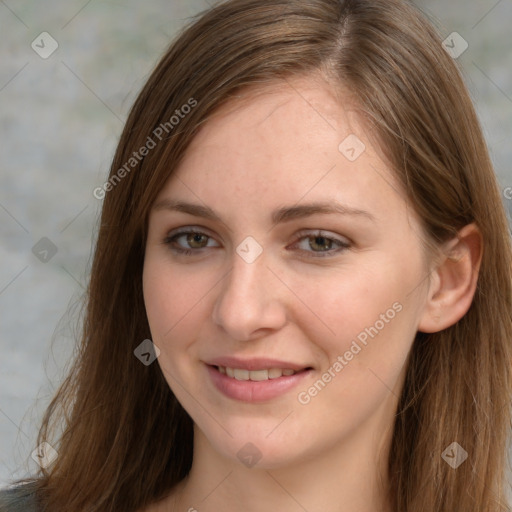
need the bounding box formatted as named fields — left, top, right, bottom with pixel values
left=159, top=77, right=404, bottom=223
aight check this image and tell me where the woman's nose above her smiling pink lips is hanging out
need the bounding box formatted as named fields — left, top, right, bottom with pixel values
left=212, top=245, right=287, bottom=341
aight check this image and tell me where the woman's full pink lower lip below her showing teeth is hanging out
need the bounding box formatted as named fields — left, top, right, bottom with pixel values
left=206, top=365, right=313, bottom=402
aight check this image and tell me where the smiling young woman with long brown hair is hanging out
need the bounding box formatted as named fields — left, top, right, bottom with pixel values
left=3, top=0, right=512, bottom=512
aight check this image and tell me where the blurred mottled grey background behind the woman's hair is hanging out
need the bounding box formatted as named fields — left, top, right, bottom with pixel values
left=0, top=0, right=512, bottom=487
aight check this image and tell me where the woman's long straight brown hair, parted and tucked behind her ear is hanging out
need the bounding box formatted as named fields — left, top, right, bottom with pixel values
left=13, top=0, right=512, bottom=512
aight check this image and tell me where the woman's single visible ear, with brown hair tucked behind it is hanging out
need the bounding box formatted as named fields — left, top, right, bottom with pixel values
left=418, top=223, right=483, bottom=333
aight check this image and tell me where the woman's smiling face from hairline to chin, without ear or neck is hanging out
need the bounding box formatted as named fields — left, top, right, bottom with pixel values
left=143, top=78, right=428, bottom=468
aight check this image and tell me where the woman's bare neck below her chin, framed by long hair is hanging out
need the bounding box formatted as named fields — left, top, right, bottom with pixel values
left=167, top=416, right=392, bottom=512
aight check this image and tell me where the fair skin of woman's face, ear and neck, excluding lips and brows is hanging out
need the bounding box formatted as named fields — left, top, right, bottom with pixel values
left=143, top=77, right=481, bottom=512
